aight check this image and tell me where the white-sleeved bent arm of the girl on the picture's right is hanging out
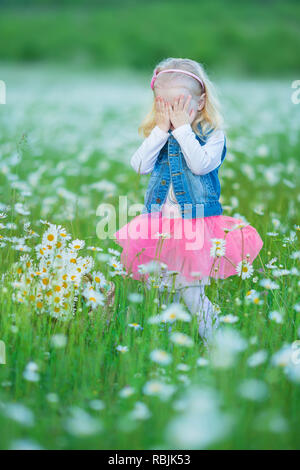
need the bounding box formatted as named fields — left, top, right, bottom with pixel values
left=172, top=124, right=225, bottom=175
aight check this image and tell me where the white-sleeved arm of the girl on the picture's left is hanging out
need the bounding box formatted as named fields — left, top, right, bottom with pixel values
left=130, top=126, right=169, bottom=175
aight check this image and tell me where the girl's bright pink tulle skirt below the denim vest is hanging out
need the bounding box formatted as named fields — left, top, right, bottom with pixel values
left=114, top=212, right=263, bottom=281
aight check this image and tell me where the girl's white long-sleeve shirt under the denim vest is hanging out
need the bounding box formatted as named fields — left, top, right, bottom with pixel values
left=130, top=124, right=225, bottom=218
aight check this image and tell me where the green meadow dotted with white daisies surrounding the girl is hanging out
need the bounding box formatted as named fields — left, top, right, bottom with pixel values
left=0, top=67, right=300, bottom=449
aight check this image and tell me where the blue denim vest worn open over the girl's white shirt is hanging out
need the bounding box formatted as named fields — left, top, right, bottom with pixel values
left=142, top=123, right=226, bottom=219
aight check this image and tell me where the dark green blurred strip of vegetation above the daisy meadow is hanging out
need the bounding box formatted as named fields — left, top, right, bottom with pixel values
left=0, top=0, right=300, bottom=78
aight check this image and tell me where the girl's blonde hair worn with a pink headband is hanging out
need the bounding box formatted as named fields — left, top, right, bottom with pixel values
left=138, top=57, right=223, bottom=137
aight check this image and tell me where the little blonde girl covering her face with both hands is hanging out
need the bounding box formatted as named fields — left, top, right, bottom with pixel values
left=114, top=58, right=263, bottom=342
